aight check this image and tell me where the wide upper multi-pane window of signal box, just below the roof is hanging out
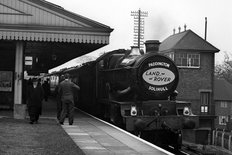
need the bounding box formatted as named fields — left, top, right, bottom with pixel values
left=174, top=53, right=200, bottom=68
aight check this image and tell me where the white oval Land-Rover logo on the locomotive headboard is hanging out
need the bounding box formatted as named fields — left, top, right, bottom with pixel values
left=142, top=68, right=175, bottom=86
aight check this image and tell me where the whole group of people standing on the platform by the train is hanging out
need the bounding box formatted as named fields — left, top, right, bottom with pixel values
left=27, top=74, right=80, bottom=125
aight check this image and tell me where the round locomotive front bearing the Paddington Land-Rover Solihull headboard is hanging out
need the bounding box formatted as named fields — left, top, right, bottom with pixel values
left=136, top=50, right=179, bottom=100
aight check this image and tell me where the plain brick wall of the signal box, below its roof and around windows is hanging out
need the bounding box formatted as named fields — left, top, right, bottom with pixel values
left=177, top=52, right=214, bottom=114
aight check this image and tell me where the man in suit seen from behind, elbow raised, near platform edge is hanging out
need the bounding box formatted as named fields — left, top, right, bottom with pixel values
left=58, top=73, right=80, bottom=125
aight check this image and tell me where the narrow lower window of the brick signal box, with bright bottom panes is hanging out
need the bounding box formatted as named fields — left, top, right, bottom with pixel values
left=200, top=91, right=210, bottom=115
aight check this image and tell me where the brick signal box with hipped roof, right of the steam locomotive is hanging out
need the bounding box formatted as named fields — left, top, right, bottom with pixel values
left=159, top=30, right=219, bottom=128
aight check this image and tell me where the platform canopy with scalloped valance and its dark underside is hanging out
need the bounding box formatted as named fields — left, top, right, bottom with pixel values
left=0, top=0, right=113, bottom=72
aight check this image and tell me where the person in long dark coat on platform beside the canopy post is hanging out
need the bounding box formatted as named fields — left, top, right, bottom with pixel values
left=27, top=79, right=44, bottom=124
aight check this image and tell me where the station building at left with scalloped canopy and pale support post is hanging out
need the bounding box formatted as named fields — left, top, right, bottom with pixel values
left=0, top=0, right=113, bottom=118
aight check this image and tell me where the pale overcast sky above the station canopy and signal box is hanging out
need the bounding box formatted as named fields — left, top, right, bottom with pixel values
left=47, top=0, right=232, bottom=71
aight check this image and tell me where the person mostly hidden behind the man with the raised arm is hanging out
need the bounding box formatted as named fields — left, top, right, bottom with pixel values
left=55, top=75, right=64, bottom=121
